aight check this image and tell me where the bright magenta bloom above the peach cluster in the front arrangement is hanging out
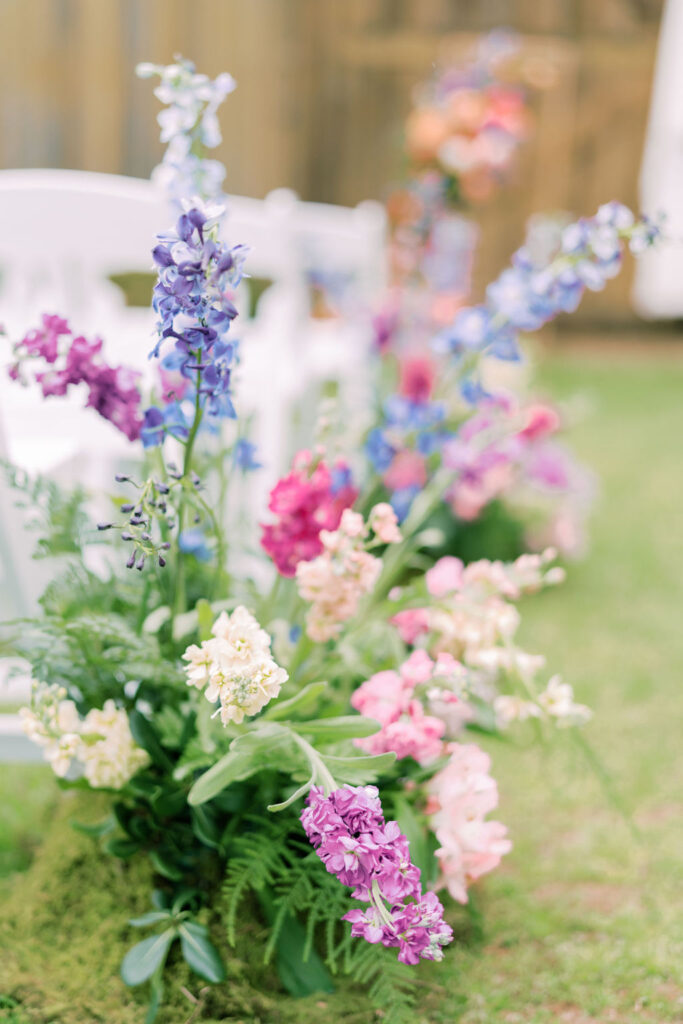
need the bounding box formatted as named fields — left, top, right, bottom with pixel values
left=261, top=451, right=357, bottom=577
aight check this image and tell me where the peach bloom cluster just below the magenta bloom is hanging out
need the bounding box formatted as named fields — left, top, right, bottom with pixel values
left=296, top=506, right=400, bottom=643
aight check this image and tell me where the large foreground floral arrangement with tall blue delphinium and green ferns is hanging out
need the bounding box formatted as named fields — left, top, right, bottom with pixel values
left=3, top=62, right=656, bottom=1021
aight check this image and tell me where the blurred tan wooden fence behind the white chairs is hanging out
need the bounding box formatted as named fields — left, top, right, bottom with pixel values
left=0, top=0, right=661, bottom=318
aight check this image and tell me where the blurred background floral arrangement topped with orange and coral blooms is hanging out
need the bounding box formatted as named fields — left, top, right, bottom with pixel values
left=365, top=32, right=657, bottom=557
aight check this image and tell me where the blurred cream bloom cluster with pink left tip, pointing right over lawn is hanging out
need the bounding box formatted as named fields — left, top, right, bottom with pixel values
left=392, top=549, right=564, bottom=665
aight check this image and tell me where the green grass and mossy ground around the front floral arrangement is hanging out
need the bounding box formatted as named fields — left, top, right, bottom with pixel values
left=0, top=346, right=683, bottom=1024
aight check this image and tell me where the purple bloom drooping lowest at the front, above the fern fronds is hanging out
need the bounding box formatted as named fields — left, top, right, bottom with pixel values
left=301, top=785, right=453, bottom=964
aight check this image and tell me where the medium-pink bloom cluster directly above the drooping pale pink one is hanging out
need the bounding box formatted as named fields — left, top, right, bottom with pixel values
left=351, top=650, right=472, bottom=765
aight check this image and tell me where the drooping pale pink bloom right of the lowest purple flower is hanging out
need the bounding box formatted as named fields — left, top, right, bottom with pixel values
left=427, top=743, right=512, bottom=903
